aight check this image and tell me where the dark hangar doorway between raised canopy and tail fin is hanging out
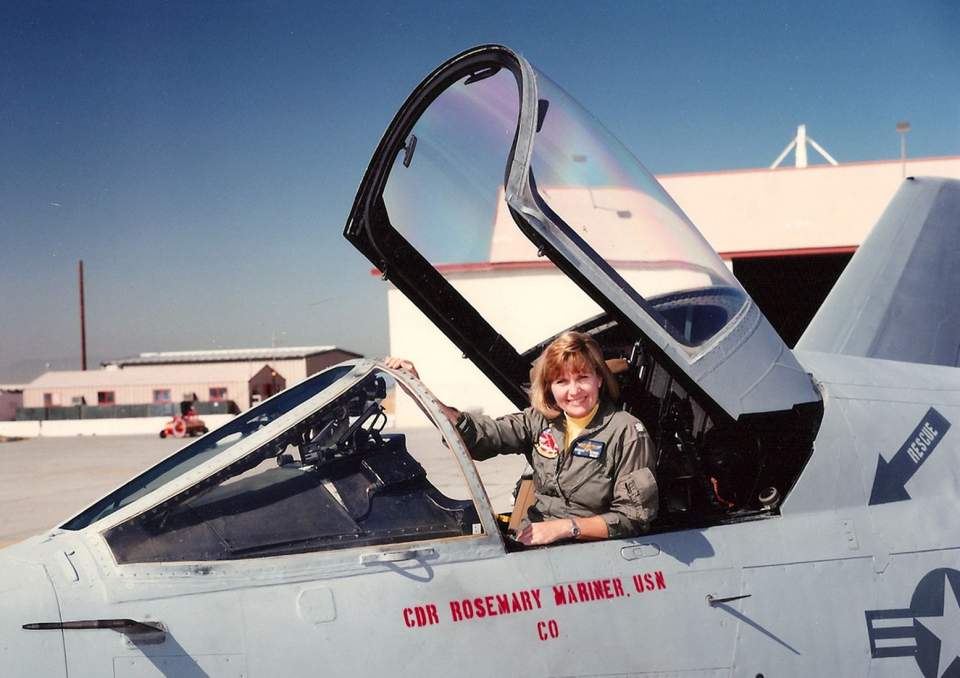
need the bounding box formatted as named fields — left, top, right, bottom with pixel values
left=732, top=247, right=856, bottom=348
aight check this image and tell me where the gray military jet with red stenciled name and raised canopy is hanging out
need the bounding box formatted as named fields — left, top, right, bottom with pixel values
left=0, top=46, right=960, bottom=678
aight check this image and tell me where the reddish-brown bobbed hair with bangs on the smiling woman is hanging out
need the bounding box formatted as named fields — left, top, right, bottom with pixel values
left=530, top=332, right=620, bottom=419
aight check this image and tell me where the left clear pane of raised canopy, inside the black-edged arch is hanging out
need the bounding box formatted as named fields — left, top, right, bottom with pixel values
left=383, top=69, right=601, bottom=355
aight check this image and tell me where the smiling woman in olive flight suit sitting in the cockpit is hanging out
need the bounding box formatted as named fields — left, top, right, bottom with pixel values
left=385, top=332, right=658, bottom=545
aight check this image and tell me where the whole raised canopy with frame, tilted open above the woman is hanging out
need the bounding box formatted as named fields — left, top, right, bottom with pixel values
left=345, top=46, right=819, bottom=419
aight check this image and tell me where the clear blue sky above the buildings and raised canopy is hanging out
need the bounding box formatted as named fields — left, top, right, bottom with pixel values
left=0, top=0, right=960, bottom=383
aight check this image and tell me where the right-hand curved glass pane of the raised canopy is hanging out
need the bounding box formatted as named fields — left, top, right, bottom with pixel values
left=528, top=73, right=747, bottom=347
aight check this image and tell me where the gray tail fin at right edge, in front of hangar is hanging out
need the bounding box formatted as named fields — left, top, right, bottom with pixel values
left=796, top=177, right=960, bottom=367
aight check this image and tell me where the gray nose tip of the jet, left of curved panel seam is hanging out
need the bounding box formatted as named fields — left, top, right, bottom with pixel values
left=0, top=555, right=67, bottom=678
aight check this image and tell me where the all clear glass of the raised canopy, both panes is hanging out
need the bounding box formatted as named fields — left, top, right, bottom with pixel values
left=383, top=62, right=747, bottom=353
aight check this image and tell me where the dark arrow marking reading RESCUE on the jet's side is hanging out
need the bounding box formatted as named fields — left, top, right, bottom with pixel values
left=870, top=407, right=950, bottom=506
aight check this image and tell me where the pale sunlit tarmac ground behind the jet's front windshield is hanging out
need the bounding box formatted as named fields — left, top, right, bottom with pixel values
left=0, top=429, right=525, bottom=547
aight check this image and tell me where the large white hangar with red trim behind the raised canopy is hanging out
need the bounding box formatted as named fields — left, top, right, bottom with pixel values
left=387, top=157, right=960, bottom=420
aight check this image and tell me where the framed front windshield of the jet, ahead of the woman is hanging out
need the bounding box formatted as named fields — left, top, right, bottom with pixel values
left=64, top=361, right=483, bottom=564
